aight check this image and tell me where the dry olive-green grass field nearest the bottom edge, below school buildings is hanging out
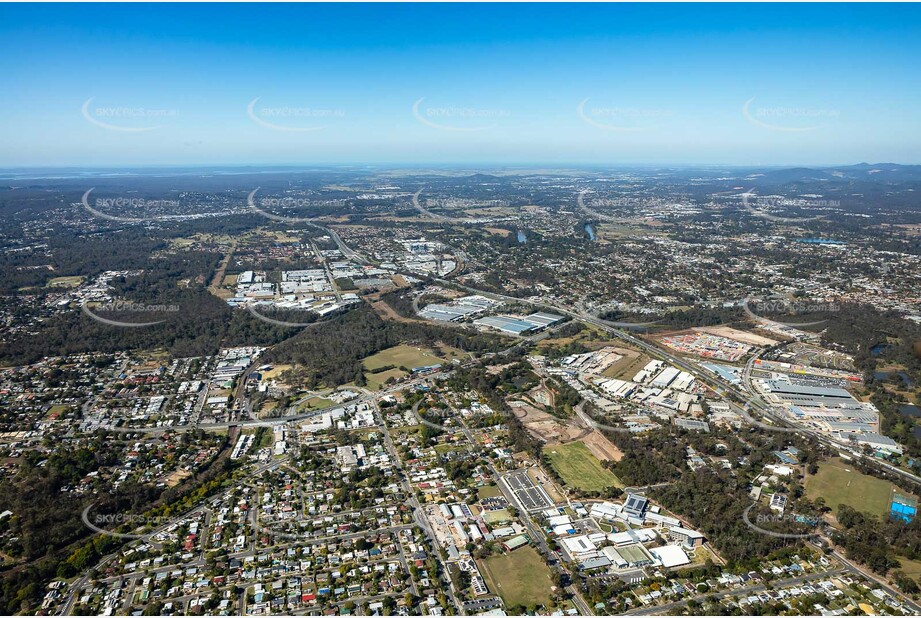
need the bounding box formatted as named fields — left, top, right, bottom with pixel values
left=479, top=546, right=553, bottom=607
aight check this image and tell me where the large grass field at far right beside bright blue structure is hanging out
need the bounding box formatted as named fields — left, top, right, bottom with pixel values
left=806, top=458, right=895, bottom=517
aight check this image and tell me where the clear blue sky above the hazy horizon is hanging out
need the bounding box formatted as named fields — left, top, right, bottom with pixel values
left=0, top=4, right=921, bottom=167
